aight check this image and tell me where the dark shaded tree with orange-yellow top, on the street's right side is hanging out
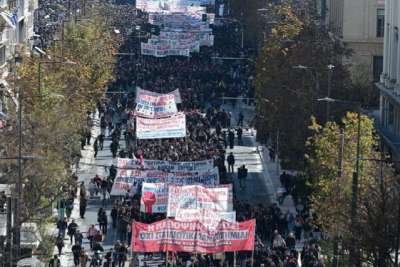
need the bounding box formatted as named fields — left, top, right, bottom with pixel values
left=254, top=1, right=351, bottom=169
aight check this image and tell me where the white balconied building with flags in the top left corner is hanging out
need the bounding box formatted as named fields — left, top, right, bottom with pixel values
left=0, top=0, right=37, bottom=119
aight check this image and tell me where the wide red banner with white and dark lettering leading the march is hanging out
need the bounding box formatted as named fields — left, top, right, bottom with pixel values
left=132, top=219, right=256, bottom=253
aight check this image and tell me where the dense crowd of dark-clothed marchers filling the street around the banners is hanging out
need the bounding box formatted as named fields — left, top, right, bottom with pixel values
left=43, top=2, right=323, bottom=267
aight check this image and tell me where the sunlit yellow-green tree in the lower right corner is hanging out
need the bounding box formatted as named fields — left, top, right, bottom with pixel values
left=306, top=113, right=400, bottom=266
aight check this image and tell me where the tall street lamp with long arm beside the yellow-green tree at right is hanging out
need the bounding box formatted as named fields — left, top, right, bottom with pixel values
left=317, top=97, right=361, bottom=267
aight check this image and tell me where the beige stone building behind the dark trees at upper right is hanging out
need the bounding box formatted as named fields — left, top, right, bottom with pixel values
left=318, top=0, right=385, bottom=82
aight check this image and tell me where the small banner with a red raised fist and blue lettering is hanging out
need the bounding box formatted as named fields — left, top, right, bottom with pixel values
left=140, top=183, right=168, bottom=214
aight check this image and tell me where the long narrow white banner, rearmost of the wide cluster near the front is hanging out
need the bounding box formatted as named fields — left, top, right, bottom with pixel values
left=117, top=158, right=214, bottom=172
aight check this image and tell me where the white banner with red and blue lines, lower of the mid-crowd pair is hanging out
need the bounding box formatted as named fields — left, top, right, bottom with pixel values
left=136, top=113, right=186, bottom=139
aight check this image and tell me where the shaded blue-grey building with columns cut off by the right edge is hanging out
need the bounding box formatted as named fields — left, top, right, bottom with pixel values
left=376, top=0, right=400, bottom=160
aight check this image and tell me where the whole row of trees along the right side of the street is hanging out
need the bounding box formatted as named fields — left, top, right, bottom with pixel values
left=254, top=1, right=400, bottom=266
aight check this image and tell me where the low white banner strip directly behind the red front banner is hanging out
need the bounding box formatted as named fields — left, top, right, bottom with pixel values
left=175, top=209, right=236, bottom=230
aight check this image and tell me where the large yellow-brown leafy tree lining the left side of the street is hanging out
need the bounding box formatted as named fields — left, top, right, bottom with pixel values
left=0, top=5, right=118, bottom=225
